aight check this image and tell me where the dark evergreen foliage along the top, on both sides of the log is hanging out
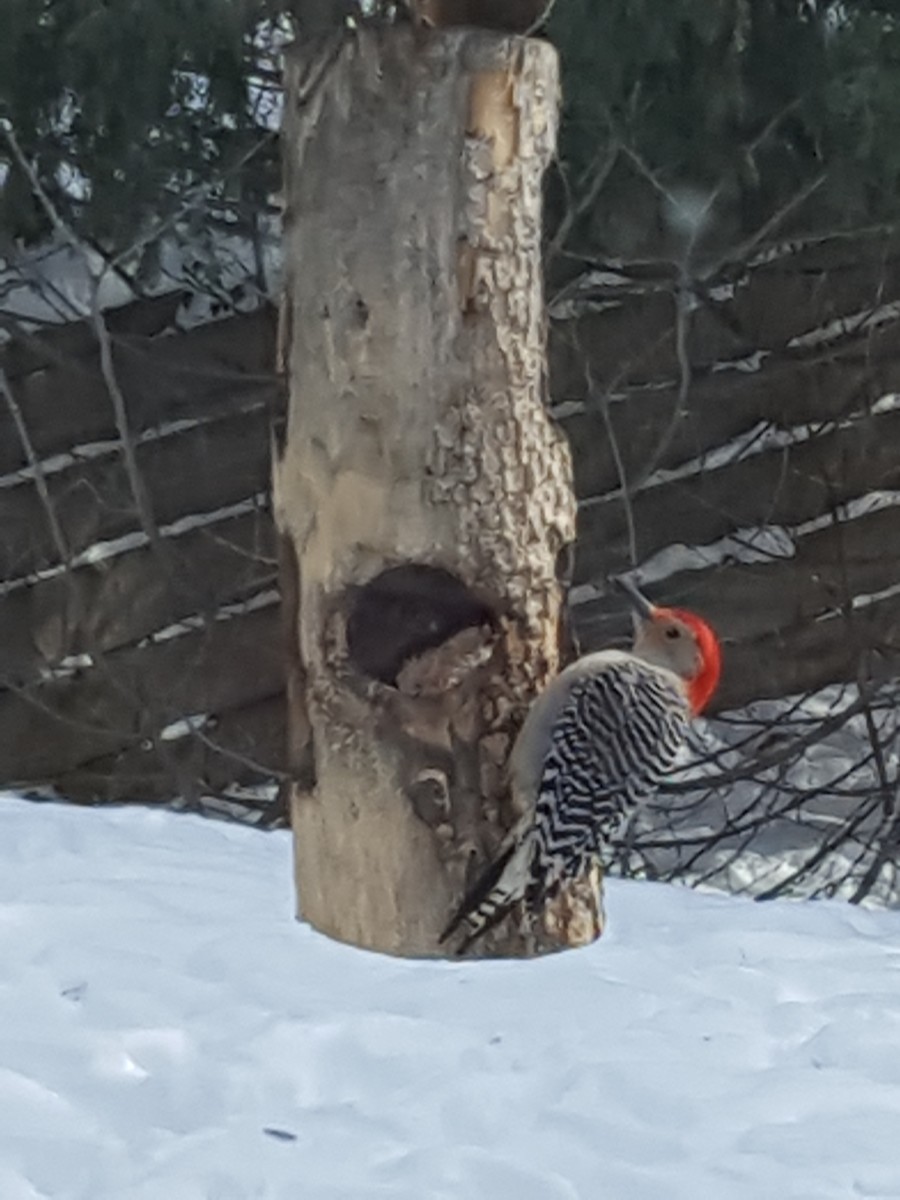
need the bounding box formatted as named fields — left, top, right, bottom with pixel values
left=0, top=0, right=900, bottom=271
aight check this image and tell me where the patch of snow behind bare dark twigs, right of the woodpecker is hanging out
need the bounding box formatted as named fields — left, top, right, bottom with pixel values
left=628, top=682, right=900, bottom=907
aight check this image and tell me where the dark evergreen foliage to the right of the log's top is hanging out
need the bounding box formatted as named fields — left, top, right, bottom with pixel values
left=550, top=0, right=900, bottom=265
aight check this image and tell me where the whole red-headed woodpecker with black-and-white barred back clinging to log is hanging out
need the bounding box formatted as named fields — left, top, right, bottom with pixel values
left=442, top=580, right=721, bottom=949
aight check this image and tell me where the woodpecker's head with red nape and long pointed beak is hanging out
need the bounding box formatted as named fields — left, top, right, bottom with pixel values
left=616, top=578, right=722, bottom=715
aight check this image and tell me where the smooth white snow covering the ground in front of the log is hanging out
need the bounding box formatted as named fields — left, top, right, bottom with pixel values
left=0, top=797, right=900, bottom=1200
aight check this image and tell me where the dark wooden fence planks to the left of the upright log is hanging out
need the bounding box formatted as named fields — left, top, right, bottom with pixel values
left=0, top=295, right=283, bottom=799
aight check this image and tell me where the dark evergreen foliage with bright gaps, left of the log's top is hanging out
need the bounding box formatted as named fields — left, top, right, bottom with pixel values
left=0, top=0, right=285, bottom=272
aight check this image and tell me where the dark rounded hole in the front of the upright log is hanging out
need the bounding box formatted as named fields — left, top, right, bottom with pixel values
left=347, top=563, right=494, bottom=685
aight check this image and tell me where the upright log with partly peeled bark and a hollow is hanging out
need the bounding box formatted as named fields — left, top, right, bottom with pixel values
left=274, top=29, right=600, bottom=955
